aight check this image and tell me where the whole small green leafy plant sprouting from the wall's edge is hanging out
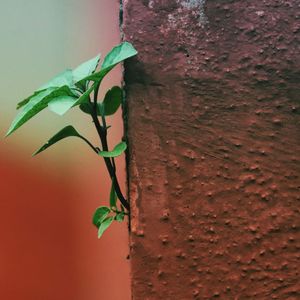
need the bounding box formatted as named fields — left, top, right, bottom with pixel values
left=6, top=42, right=137, bottom=238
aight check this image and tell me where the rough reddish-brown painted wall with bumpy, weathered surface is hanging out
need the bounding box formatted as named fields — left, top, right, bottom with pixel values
left=124, top=0, right=300, bottom=300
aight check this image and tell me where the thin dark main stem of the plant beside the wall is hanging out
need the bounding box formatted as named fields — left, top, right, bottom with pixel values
left=91, top=83, right=130, bottom=211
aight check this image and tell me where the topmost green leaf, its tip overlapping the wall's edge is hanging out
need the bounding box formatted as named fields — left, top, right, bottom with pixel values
left=78, top=42, right=137, bottom=82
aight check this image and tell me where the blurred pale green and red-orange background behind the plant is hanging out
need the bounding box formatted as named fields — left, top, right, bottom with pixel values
left=0, top=0, right=130, bottom=300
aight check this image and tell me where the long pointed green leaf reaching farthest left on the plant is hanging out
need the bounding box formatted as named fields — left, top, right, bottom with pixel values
left=6, top=86, right=73, bottom=136
